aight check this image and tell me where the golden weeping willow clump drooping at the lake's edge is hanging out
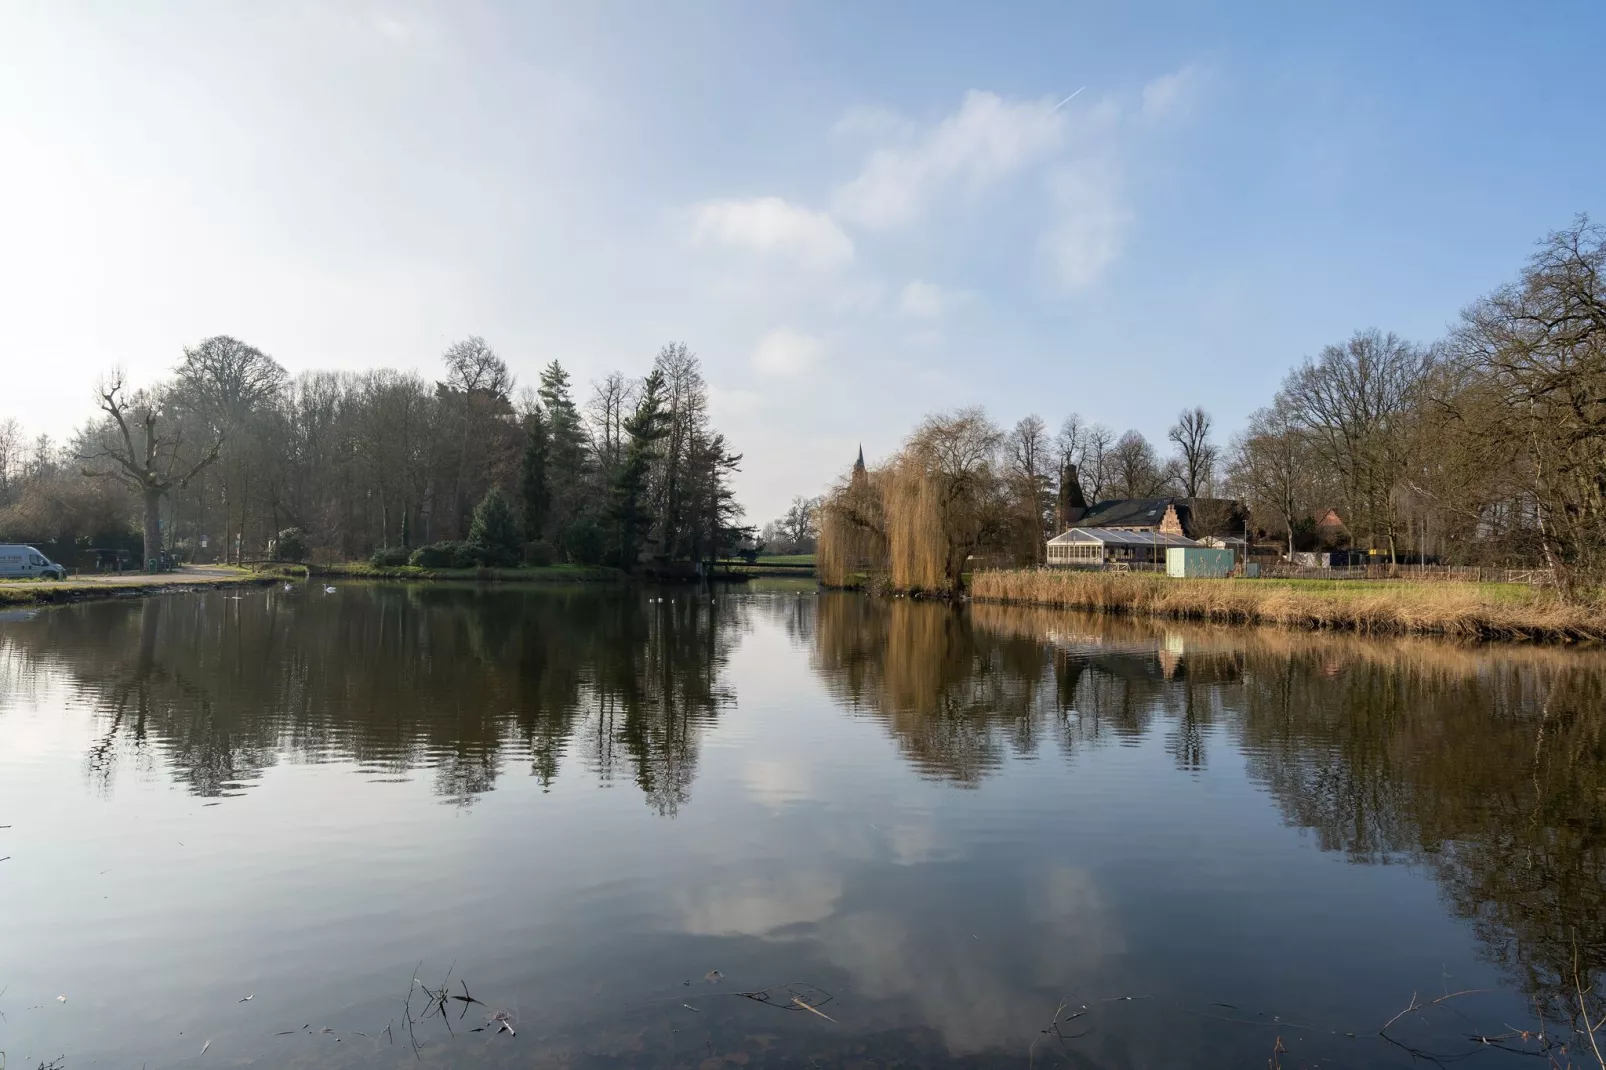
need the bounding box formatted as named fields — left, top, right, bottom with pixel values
left=816, top=408, right=1020, bottom=594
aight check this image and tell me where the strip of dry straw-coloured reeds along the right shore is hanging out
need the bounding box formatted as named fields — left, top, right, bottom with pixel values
left=970, top=569, right=1606, bottom=641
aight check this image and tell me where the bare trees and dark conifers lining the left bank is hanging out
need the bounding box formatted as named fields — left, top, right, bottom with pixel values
left=0, top=336, right=752, bottom=569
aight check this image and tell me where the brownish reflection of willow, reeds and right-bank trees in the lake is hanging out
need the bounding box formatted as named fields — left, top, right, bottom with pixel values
left=813, top=596, right=1606, bottom=1022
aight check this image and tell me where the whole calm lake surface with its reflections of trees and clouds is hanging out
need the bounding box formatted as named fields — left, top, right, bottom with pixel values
left=0, top=582, right=1606, bottom=1070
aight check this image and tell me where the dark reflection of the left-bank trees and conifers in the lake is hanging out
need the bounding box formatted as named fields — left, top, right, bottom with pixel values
left=0, top=585, right=737, bottom=815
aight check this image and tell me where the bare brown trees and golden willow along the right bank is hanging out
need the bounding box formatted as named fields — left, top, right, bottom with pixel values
left=819, top=218, right=1606, bottom=598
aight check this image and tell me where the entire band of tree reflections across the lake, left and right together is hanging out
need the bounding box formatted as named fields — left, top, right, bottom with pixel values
left=0, top=585, right=1606, bottom=1047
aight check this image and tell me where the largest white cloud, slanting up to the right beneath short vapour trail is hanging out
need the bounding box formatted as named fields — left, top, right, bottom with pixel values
left=835, top=90, right=1065, bottom=228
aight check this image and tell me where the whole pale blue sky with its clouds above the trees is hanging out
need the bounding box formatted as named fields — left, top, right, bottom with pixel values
left=0, top=0, right=1606, bottom=522
